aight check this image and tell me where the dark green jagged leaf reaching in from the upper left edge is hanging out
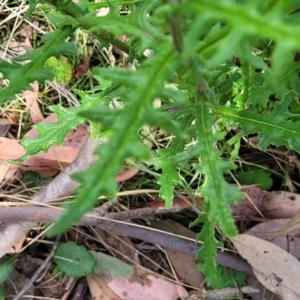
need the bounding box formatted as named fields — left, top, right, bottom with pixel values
left=0, top=27, right=75, bottom=105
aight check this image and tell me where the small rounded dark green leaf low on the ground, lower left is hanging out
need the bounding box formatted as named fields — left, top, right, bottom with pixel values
left=53, top=242, right=96, bottom=278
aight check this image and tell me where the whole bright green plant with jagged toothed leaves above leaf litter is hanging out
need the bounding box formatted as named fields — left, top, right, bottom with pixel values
left=0, top=0, right=300, bottom=277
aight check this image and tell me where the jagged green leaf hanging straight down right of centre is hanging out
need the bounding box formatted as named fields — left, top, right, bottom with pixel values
left=196, top=100, right=243, bottom=236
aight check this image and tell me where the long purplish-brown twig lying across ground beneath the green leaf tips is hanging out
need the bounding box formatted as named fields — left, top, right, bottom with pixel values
left=0, top=206, right=253, bottom=275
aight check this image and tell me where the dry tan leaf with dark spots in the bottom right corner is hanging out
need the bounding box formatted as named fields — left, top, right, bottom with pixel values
left=231, top=234, right=300, bottom=300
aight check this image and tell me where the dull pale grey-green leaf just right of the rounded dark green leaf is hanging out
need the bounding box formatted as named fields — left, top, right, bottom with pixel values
left=90, top=251, right=135, bottom=279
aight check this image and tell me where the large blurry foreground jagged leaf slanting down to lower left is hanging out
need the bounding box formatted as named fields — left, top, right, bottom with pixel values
left=50, top=48, right=181, bottom=235
